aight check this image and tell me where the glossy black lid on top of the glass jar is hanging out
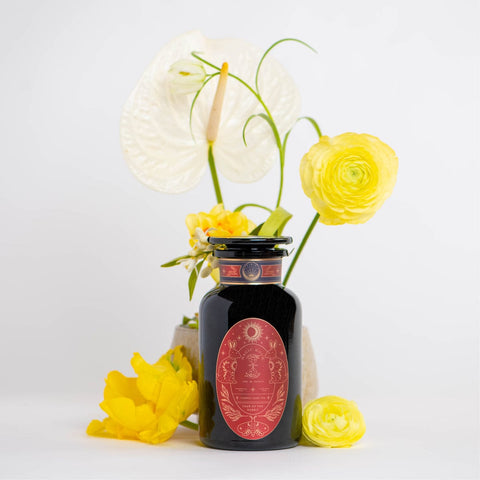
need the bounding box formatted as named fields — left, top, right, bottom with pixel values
left=208, top=235, right=292, bottom=258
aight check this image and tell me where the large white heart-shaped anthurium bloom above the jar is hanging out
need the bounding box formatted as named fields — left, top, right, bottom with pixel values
left=120, top=31, right=300, bottom=193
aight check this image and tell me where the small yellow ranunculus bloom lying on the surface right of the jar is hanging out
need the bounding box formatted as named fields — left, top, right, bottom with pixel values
left=302, top=395, right=365, bottom=447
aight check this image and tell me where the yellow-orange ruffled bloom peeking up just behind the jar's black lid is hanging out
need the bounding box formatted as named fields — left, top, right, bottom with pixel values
left=185, top=203, right=255, bottom=239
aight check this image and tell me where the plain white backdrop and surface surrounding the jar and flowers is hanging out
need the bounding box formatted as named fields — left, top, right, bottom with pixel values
left=0, top=0, right=480, bottom=479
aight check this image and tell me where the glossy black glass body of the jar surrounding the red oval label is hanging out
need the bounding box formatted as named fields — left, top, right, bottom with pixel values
left=199, top=284, right=302, bottom=450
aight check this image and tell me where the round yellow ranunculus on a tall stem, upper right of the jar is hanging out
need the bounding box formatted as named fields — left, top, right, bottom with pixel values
left=300, top=133, right=398, bottom=225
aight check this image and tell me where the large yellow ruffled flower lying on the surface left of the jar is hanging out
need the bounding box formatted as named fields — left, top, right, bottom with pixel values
left=87, top=346, right=198, bottom=444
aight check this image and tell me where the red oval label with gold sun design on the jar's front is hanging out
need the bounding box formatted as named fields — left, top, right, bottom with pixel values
left=216, top=318, right=288, bottom=440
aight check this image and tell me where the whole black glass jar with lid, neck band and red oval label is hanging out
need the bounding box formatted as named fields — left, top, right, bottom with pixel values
left=199, top=236, right=302, bottom=450
